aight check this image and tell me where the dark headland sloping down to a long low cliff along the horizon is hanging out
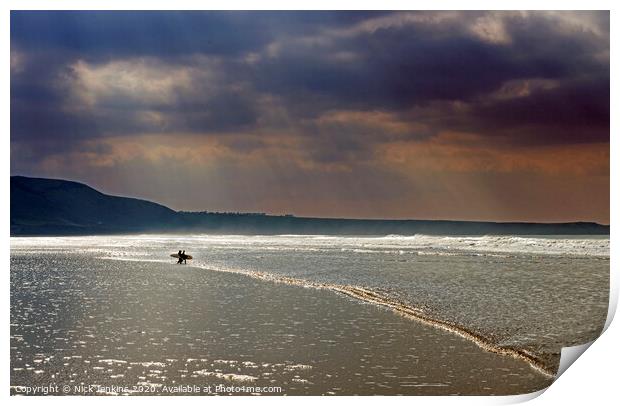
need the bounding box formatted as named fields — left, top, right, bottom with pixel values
left=11, top=176, right=609, bottom=236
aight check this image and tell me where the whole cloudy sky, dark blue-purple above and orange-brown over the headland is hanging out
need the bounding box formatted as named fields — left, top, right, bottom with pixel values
left=10, top=11, right=610, bottom=224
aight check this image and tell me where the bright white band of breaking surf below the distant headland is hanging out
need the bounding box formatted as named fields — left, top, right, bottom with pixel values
left=11, top=234, right=609, bottom=258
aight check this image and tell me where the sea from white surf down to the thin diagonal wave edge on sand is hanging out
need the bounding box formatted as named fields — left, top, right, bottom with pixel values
left=11, top=235, right=609, bottom=373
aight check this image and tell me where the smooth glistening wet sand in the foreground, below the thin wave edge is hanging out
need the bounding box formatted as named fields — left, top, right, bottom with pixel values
left=11, top=253, right=551, bottom=395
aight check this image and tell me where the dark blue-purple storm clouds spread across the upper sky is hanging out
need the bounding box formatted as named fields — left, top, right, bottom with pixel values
left=11, top=12, right=609, bottom=147
